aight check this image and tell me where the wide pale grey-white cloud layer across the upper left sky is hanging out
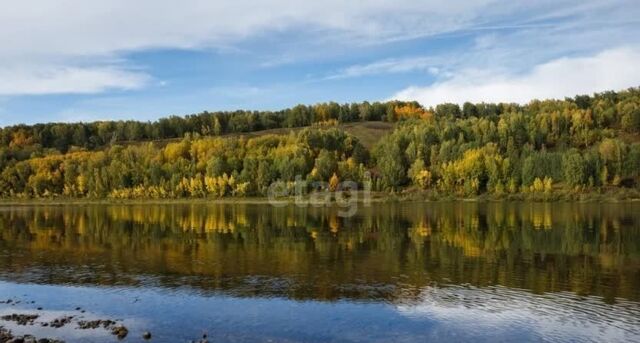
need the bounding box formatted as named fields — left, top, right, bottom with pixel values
left=0, top=0, right=496, bottom=95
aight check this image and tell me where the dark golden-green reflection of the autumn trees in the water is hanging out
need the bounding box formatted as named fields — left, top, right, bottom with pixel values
left=0, top=203, right=640, bottom=300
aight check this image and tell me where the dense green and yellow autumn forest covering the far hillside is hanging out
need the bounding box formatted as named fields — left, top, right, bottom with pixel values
left=0, top=88, right=640, bottom=198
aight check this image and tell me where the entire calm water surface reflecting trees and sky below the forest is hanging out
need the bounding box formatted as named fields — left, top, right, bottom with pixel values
left=0, top=203, right=640, bottom=342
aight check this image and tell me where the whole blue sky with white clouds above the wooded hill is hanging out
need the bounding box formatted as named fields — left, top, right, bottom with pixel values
left=0, top=0, right=640, bottom=126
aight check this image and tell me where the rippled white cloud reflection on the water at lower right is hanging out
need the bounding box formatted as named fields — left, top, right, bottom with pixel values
left=397, top=286, right=640, bottom=342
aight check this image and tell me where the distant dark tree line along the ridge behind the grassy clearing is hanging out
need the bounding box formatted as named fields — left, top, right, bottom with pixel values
left=0, top=101, right=418, bottom=156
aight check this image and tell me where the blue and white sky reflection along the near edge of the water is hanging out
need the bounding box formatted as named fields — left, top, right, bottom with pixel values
left=0, top=282, right=640, bottom=342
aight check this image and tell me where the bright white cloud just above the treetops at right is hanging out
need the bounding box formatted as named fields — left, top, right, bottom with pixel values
left=392, top=47, right=640, bottom=106
